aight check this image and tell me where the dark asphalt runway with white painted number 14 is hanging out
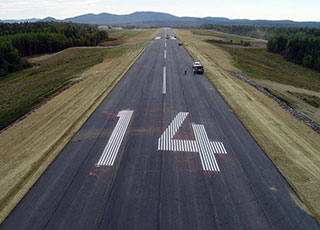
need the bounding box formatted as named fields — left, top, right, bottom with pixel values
left=0, top=29, right=320, bottom=230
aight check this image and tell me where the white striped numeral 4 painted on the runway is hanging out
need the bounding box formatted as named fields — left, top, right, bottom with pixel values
left=158, top=112, right=227, bottom=172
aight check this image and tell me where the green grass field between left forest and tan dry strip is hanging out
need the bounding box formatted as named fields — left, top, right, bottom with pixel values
left=0, top=48, right=125, bottom=129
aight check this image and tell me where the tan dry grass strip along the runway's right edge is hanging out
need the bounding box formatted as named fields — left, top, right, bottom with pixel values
left=174, top=30, right=320, bottom=221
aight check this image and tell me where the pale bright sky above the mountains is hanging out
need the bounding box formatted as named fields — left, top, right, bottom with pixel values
left=0, top=0, right=320, bottom=21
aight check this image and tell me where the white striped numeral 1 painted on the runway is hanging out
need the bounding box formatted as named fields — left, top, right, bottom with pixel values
left=96, top=110, right=133, bottom=167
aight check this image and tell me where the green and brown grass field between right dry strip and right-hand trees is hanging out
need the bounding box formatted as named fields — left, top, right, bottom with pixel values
left=192, top=30, right=320, bottom=124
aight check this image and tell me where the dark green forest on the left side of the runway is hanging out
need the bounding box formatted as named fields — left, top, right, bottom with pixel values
left=0, top=22, right=108, bottom=77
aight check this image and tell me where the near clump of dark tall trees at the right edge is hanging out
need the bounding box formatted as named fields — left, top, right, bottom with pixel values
left=267, top=32, right=320, bottom=72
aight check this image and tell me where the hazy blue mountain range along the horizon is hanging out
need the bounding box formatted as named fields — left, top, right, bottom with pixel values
left=0, top=12, right=320, bottom=28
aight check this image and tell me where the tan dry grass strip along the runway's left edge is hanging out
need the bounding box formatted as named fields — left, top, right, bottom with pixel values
left=0, top=30, right=157, bottom=223
